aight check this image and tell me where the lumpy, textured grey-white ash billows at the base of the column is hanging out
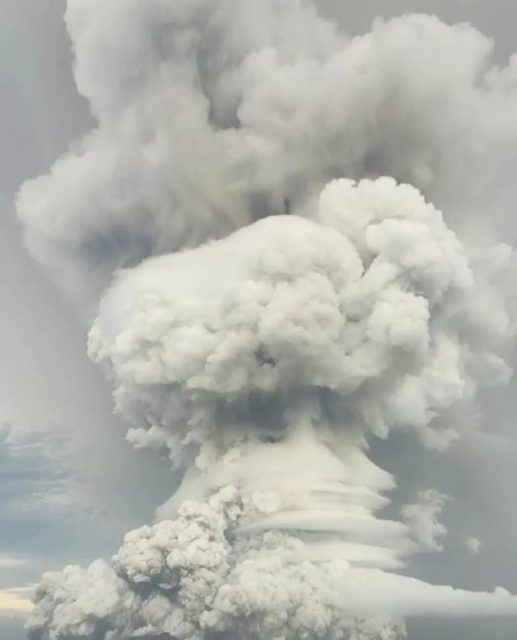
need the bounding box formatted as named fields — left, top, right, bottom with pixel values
left=27, top=487, right=406, bottom=640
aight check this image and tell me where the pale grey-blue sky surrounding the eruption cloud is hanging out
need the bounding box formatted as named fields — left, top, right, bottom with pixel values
left=0, top=0, right=517, bottom=640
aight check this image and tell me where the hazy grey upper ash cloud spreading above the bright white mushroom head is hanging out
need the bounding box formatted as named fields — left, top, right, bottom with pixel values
left=18, top=0, right=517, bottom=309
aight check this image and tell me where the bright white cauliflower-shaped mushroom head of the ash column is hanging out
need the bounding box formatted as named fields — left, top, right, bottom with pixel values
left=90, top=178, right=512, bottom=455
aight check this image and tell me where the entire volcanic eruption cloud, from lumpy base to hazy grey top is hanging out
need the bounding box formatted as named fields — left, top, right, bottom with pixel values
left=18, top=0, right=517, bottom=640
